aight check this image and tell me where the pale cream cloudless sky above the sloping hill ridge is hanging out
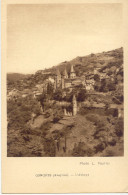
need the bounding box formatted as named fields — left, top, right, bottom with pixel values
left=7, top=3, right=123, bottom=74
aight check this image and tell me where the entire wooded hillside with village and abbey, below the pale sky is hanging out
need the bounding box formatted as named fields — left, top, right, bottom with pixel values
left=7, top=48, right=123, bottom=157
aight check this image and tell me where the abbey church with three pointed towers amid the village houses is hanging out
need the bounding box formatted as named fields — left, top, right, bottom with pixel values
left=54, top=65, right=85, bottom=90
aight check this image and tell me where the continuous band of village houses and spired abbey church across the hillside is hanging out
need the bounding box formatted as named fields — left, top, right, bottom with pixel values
left=7, top=65, right=117, bottom=100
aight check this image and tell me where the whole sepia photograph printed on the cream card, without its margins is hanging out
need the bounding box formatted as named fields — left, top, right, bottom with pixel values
left=6, top=3, right=124, bottom=157
